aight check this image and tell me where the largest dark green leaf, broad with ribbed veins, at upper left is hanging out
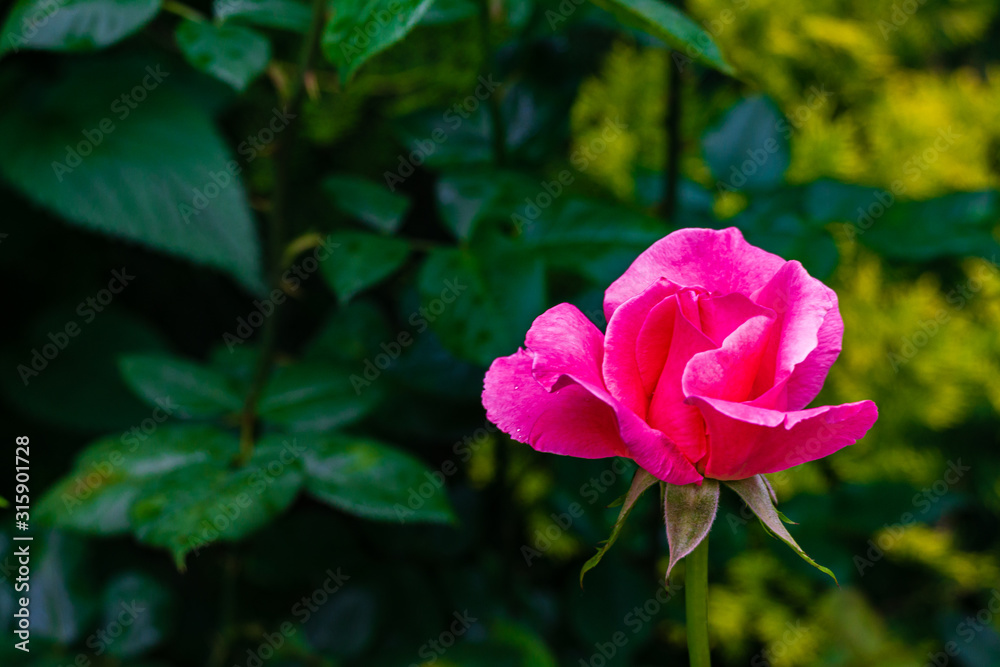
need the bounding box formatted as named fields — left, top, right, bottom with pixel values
left=0, top=58, right=263, bottom=292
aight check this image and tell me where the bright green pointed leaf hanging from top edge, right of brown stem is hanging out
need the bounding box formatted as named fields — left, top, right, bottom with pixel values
left=321, top=0, right=434, bottom=82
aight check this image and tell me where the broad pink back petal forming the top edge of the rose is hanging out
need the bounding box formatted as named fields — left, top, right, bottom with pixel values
left=604, top=227, right=785, bottom=321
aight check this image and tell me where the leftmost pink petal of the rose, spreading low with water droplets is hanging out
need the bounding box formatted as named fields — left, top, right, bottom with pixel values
left=483, top=350, right=629, bottom=459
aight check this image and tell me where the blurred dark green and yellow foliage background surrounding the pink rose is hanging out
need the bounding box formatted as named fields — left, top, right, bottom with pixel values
left=0, top=0, right=1000, bottom=667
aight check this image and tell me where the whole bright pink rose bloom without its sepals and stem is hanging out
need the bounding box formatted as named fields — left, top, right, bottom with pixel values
left=483, top=228, right=878, bottom=484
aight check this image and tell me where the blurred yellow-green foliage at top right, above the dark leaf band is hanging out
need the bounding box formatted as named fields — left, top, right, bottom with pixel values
left=572, top=0, right=1000, bottom=200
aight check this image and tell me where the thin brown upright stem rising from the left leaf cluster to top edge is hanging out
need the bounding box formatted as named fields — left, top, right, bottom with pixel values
left=239, top=0, right=326, bottom=463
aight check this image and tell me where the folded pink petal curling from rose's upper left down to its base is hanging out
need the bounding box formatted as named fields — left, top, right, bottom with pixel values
left=525, top=304, right=702, bottom=484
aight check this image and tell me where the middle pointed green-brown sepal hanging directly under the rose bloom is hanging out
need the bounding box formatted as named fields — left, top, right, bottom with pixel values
left=663, top=479, right=719, bottom=581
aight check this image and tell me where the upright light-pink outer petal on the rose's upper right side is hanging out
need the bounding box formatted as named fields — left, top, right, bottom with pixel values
left=753, top=261, right=844, bottom=410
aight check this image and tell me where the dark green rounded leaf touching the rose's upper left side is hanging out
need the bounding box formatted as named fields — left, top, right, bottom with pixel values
left=419, top=235, right=546, bottom=367
